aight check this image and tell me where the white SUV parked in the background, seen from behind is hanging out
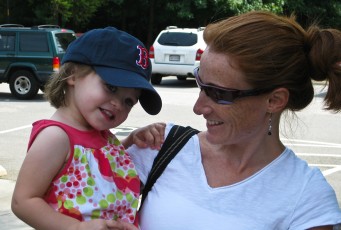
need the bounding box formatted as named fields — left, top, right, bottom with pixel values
left=149, top=26, right=206, bottom=85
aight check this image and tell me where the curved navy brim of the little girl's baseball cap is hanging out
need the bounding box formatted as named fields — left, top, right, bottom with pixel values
left=93, top=66, right=162, bottom=115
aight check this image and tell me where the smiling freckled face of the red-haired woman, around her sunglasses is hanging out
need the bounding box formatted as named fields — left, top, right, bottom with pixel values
left=193, top=47, right=269, bottom=144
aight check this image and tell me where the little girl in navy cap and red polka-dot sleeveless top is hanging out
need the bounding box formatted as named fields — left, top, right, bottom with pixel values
left=12, top=27, right=164, bottom=230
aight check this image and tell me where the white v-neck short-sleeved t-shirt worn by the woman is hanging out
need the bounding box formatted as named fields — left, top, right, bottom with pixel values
left=128, top=125, right=341, bottom=230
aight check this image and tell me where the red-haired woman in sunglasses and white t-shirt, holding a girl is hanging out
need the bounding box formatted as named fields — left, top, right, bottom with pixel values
left=128, top=12, right=341, bottom=230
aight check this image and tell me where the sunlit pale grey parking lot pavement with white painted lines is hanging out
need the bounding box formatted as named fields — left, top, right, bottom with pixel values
left=0, top=79, right=341, bottom=230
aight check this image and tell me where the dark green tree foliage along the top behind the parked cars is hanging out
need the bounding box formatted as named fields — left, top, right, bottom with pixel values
left=0, top=0, right=341, bottom=45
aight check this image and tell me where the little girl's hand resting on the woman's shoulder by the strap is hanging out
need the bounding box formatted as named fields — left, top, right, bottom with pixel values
left=122, top=122, right=166, bottom=150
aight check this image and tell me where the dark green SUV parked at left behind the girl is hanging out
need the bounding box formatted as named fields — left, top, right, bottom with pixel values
left=0, top=24, right=76, bottom=99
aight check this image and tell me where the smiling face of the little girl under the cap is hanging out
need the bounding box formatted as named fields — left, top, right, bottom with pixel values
left=68, top=71, right=141, bottom=130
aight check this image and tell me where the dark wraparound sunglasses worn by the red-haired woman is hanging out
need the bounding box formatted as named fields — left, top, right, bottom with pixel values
left=194, top=67, right=275, bottom=105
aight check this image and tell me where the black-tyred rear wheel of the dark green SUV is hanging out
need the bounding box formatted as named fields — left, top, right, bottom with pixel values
left=9, top=70, right=39, bottom=99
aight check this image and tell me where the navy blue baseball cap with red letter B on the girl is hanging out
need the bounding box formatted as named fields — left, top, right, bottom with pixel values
left=62, top=27, right=162, bottom=115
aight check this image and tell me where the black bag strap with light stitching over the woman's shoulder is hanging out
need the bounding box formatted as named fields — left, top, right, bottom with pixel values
left=140, top=125, right=199, bottom=208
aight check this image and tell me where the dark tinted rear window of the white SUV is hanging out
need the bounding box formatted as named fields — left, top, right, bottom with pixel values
left=158, top=32, right=198, bottom=46
